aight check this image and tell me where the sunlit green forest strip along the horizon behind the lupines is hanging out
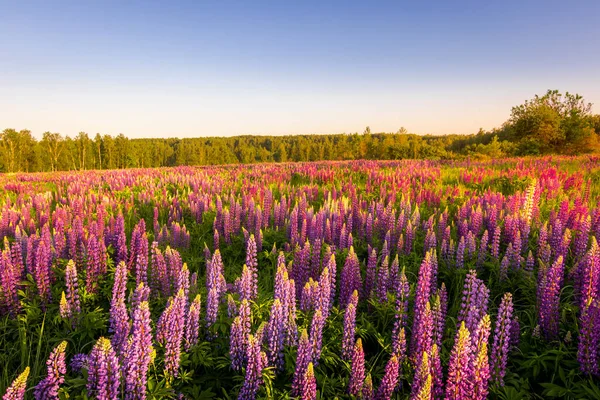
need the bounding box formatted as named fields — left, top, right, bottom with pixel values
left=0, top=90, right=600, bottom=172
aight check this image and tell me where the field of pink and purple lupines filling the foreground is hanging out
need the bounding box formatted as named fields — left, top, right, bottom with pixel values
left=0, top=157, right=600, bottom=400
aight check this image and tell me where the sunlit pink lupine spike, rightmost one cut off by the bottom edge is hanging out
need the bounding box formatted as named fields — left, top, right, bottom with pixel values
left=472, top=315, right=491, bottom=400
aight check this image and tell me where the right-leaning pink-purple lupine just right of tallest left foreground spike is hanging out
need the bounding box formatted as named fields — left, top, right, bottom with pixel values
left=156, top=289, right=186, bottom=377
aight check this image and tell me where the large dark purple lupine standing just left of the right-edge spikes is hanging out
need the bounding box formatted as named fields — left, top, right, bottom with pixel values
left=538, top=256, right=565, bottom=340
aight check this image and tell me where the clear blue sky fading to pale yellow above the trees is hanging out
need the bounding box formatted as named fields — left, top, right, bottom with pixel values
left=0, top=0, right=600, bottom=138
